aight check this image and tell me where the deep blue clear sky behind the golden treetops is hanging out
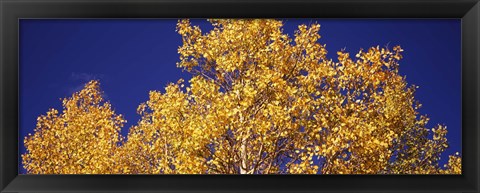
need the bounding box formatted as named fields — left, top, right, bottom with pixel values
left=19, top=19, right=461, bottom=173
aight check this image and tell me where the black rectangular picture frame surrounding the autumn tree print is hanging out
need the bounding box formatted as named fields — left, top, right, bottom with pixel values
left=0, top=0, right=480, bottom=192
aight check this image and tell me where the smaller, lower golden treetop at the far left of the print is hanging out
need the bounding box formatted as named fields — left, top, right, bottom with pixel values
left=22, top=81, right=125, bottom=174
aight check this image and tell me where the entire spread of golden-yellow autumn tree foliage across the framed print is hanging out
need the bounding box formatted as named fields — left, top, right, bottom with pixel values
left=22, top=19, right=461, bottom=174
